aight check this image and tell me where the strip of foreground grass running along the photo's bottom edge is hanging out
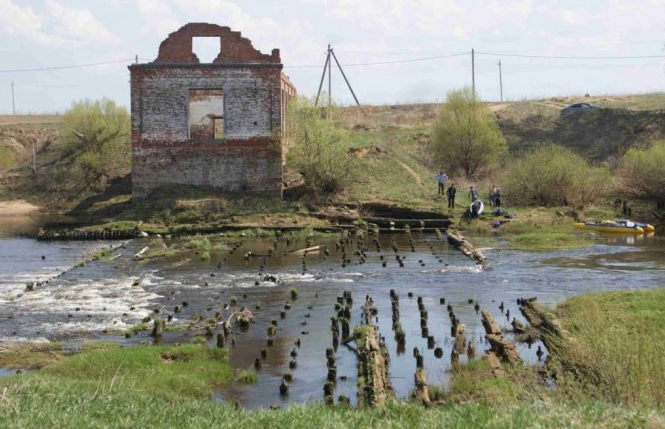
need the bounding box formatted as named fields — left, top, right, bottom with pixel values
left=0, top=386, right=665, bottom=429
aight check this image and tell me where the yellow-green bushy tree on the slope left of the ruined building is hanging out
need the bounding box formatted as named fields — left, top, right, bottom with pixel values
left=60, top=98, right=131, bottom=189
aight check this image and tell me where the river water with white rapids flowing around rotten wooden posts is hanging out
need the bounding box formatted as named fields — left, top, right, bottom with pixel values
left=0, top=216, right=665, bottom=408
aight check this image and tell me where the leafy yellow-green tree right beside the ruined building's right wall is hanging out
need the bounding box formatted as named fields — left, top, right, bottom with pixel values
left=285, top=97, right=352, bottom=195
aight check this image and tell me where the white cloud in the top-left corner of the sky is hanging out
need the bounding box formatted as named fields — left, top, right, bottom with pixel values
left=0, top=0, right=118, bottom=48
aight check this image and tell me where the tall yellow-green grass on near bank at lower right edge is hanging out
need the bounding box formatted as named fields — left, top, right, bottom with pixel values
left=551, top=289, right=665, bottom=407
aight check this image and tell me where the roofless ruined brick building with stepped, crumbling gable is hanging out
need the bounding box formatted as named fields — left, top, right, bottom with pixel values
left=129, top=23, right=296, bottom=197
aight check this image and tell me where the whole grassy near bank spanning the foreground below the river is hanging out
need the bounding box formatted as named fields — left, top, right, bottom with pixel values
left=0, top=290, right=665, bottom=428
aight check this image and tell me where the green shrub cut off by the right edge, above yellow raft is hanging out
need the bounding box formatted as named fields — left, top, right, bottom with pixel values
left=619, top=140, right=665, bottom=201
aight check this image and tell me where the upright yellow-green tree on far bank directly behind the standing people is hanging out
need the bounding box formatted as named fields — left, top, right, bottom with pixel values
left=431, top=88, right=508, bottom=178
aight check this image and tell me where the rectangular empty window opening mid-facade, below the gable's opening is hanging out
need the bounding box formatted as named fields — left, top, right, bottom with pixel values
left=189, top=89, right=224, bottom=140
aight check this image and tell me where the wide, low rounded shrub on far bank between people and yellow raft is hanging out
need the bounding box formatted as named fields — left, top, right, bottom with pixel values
left=504, top=145, right=610, bottom=206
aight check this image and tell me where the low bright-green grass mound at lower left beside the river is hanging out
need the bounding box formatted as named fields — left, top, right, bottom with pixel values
left=0, top=345, right=232, bottom=402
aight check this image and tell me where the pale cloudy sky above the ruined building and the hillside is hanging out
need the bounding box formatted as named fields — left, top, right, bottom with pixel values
left=0, top=0, right=665, bottom=113
